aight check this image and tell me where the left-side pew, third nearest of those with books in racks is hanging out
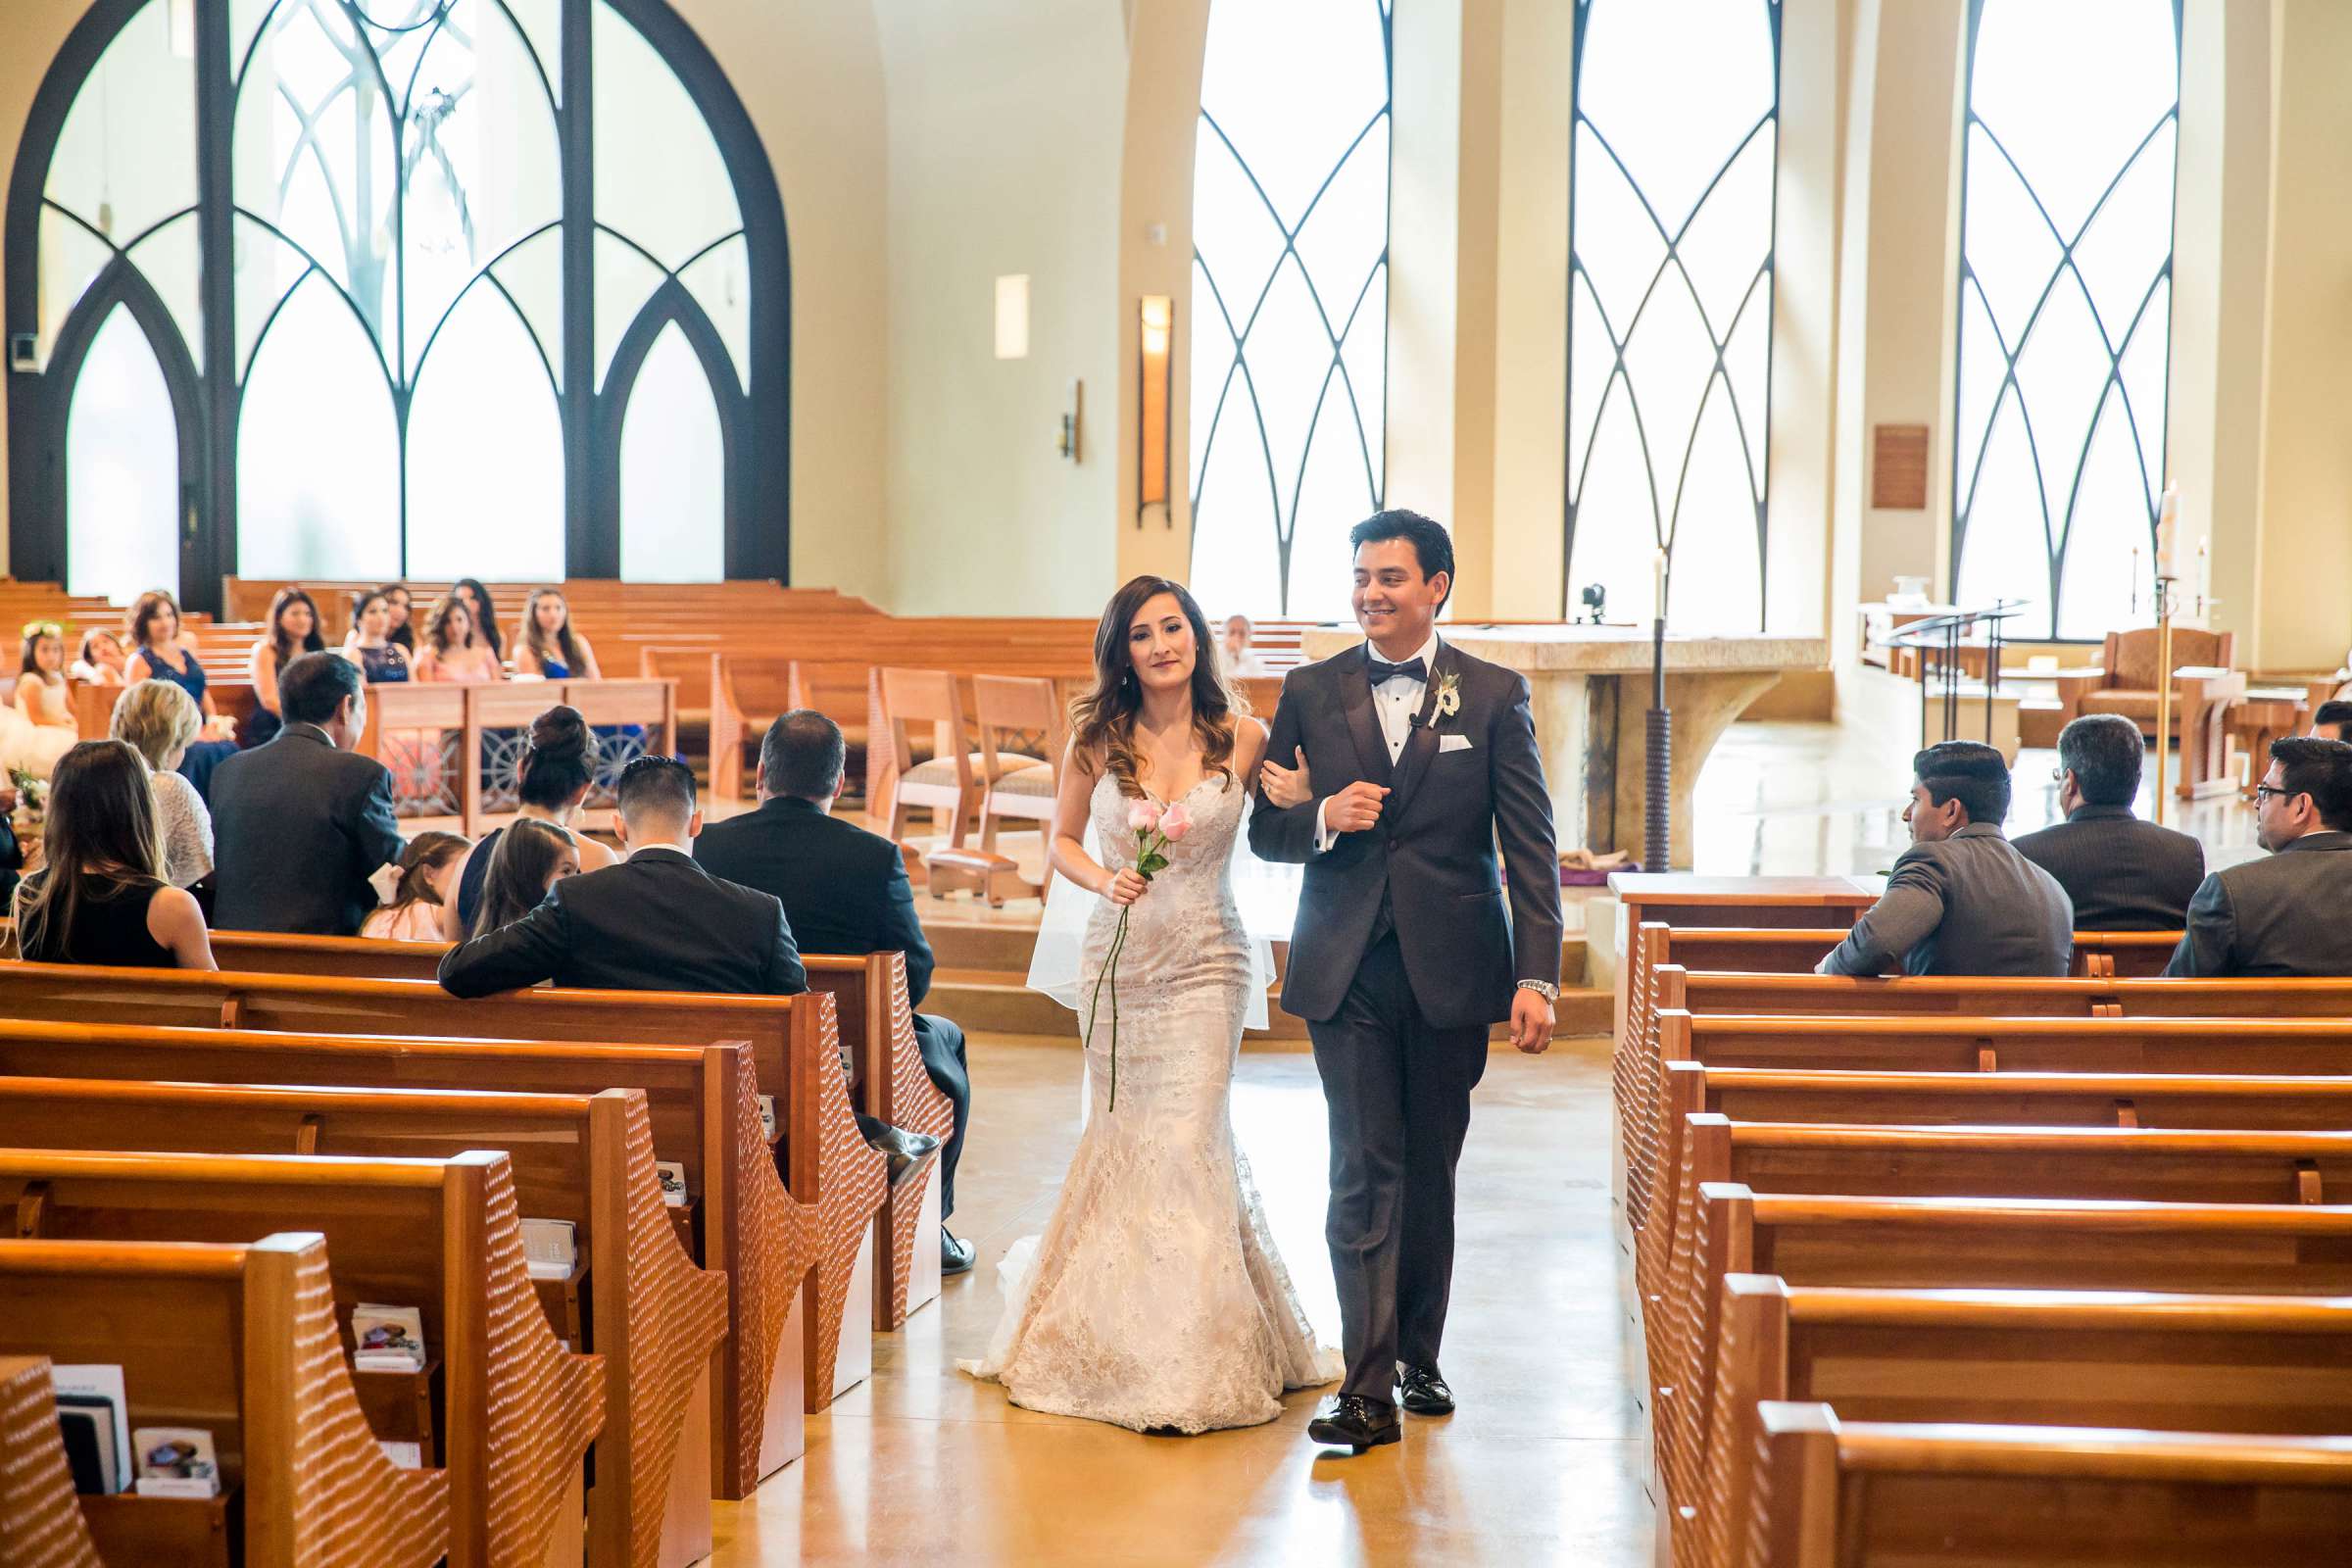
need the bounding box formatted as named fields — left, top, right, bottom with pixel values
left=0, top=1071, right=727, bottom=1568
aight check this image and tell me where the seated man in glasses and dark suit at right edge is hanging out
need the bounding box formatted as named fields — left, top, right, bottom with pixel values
left=2164, top=736, right=2352, bottom=978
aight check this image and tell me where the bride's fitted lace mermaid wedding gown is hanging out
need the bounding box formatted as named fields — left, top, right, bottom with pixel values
left=957, top=773, right=1341, bottom=1432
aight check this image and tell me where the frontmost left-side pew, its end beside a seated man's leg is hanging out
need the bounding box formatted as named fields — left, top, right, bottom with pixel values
left=185, top=931, right=955, bottom=1333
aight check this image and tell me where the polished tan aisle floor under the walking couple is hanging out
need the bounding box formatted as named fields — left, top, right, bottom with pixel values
left=712, top=1034, right=1648, bottom=1568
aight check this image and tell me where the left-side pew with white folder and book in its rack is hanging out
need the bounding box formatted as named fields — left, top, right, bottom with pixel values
left=0, top=1232, right=449, bottom=1568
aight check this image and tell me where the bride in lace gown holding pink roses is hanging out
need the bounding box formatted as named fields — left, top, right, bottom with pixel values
left=959, top=576, right=1341, bottom=1432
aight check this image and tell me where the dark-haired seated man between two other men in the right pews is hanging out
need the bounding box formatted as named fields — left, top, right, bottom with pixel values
left=2016, top=712, right=2204, bottom=931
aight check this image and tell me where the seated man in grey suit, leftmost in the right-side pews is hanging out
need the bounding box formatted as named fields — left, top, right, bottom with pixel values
left=1816, top=741, right=2075, bottom=976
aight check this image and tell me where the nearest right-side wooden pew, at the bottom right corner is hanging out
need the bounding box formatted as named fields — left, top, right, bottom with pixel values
left=1742, top=1403, right=2352, bottom=1568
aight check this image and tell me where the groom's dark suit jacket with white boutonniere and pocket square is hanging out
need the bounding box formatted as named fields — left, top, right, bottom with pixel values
left=1249, top=639, right=1559, bottom=1027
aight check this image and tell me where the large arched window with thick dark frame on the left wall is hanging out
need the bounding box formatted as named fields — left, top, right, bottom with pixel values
left=7, top=0, right=790, bottom=602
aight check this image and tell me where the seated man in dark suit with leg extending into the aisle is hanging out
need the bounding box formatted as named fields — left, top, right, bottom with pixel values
left=694, top=708, right=974, bottom=1274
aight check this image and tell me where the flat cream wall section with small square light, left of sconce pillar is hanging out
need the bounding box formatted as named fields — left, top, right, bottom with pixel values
left=875, top=0, right=1127, bottom=615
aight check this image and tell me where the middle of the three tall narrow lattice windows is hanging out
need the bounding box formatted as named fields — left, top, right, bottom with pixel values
left=1562, top=0, right=1781, bottom=632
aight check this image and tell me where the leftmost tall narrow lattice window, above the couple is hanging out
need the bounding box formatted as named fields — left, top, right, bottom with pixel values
left=1190, top=0, right=1390, bottom=618
